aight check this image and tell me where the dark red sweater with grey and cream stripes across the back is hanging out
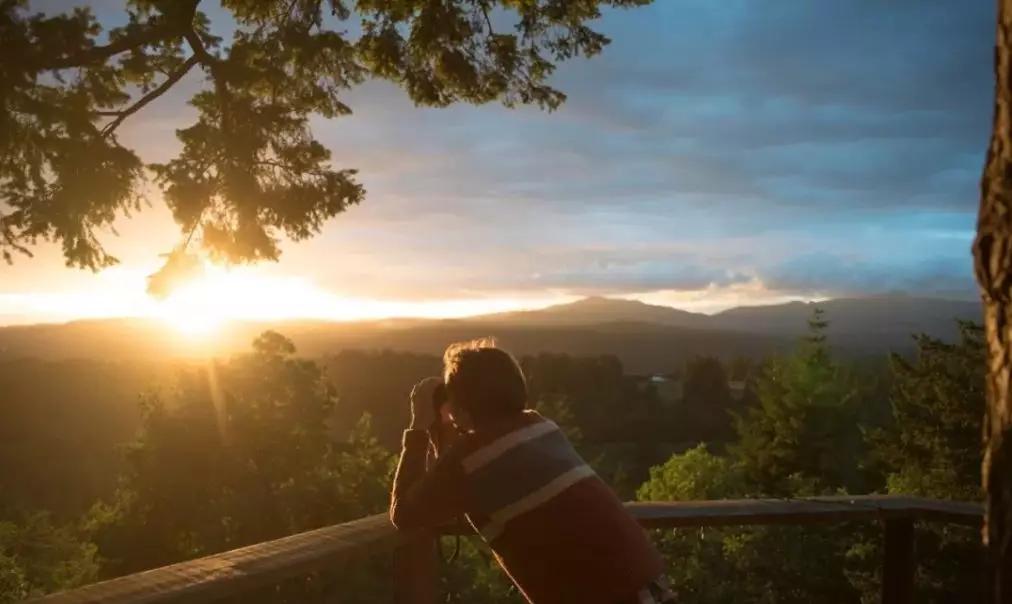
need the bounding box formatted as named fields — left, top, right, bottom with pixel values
left=391, top=412, right=662, bottom=604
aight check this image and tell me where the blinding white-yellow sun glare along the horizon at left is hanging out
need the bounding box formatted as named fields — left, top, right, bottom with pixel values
left=0, top=265, right=578, bottom=329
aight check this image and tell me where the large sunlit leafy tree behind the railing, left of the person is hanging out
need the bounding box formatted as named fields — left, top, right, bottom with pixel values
left=91, top=332, right=393, bottom=575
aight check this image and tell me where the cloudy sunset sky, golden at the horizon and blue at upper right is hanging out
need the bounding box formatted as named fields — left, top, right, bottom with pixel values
left=0, top=0, right=994, bottom=324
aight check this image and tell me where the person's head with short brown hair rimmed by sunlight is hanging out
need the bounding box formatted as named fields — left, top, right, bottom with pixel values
left=443, top=338, right=527, bottom=428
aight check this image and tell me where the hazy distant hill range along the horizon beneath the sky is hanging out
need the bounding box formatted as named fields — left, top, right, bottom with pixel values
left=0, top=294, right=981, bottom=372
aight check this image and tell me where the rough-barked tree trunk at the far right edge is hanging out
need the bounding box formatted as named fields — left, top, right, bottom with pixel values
left=974, top=0, right=1012, bottom=604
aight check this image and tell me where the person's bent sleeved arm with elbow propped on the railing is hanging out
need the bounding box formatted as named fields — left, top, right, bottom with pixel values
left=390, top=430, right=465, bottom=530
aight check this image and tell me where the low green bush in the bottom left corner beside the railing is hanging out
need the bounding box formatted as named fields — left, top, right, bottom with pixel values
left=0, top=512, right=99, bottom=602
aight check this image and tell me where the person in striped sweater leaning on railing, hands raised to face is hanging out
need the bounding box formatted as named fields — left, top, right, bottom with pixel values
left=390, top=339, right=674, bottom=604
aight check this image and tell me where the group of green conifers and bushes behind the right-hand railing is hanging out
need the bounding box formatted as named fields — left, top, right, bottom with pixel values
left=638, top=317, right=984, bottom=603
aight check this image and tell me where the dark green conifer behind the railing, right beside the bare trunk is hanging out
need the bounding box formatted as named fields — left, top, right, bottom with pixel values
left=868, top=323, right=986, bottom=602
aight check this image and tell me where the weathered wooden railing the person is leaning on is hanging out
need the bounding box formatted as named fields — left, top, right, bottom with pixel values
left=34, top=495, right=983, bottom=604
